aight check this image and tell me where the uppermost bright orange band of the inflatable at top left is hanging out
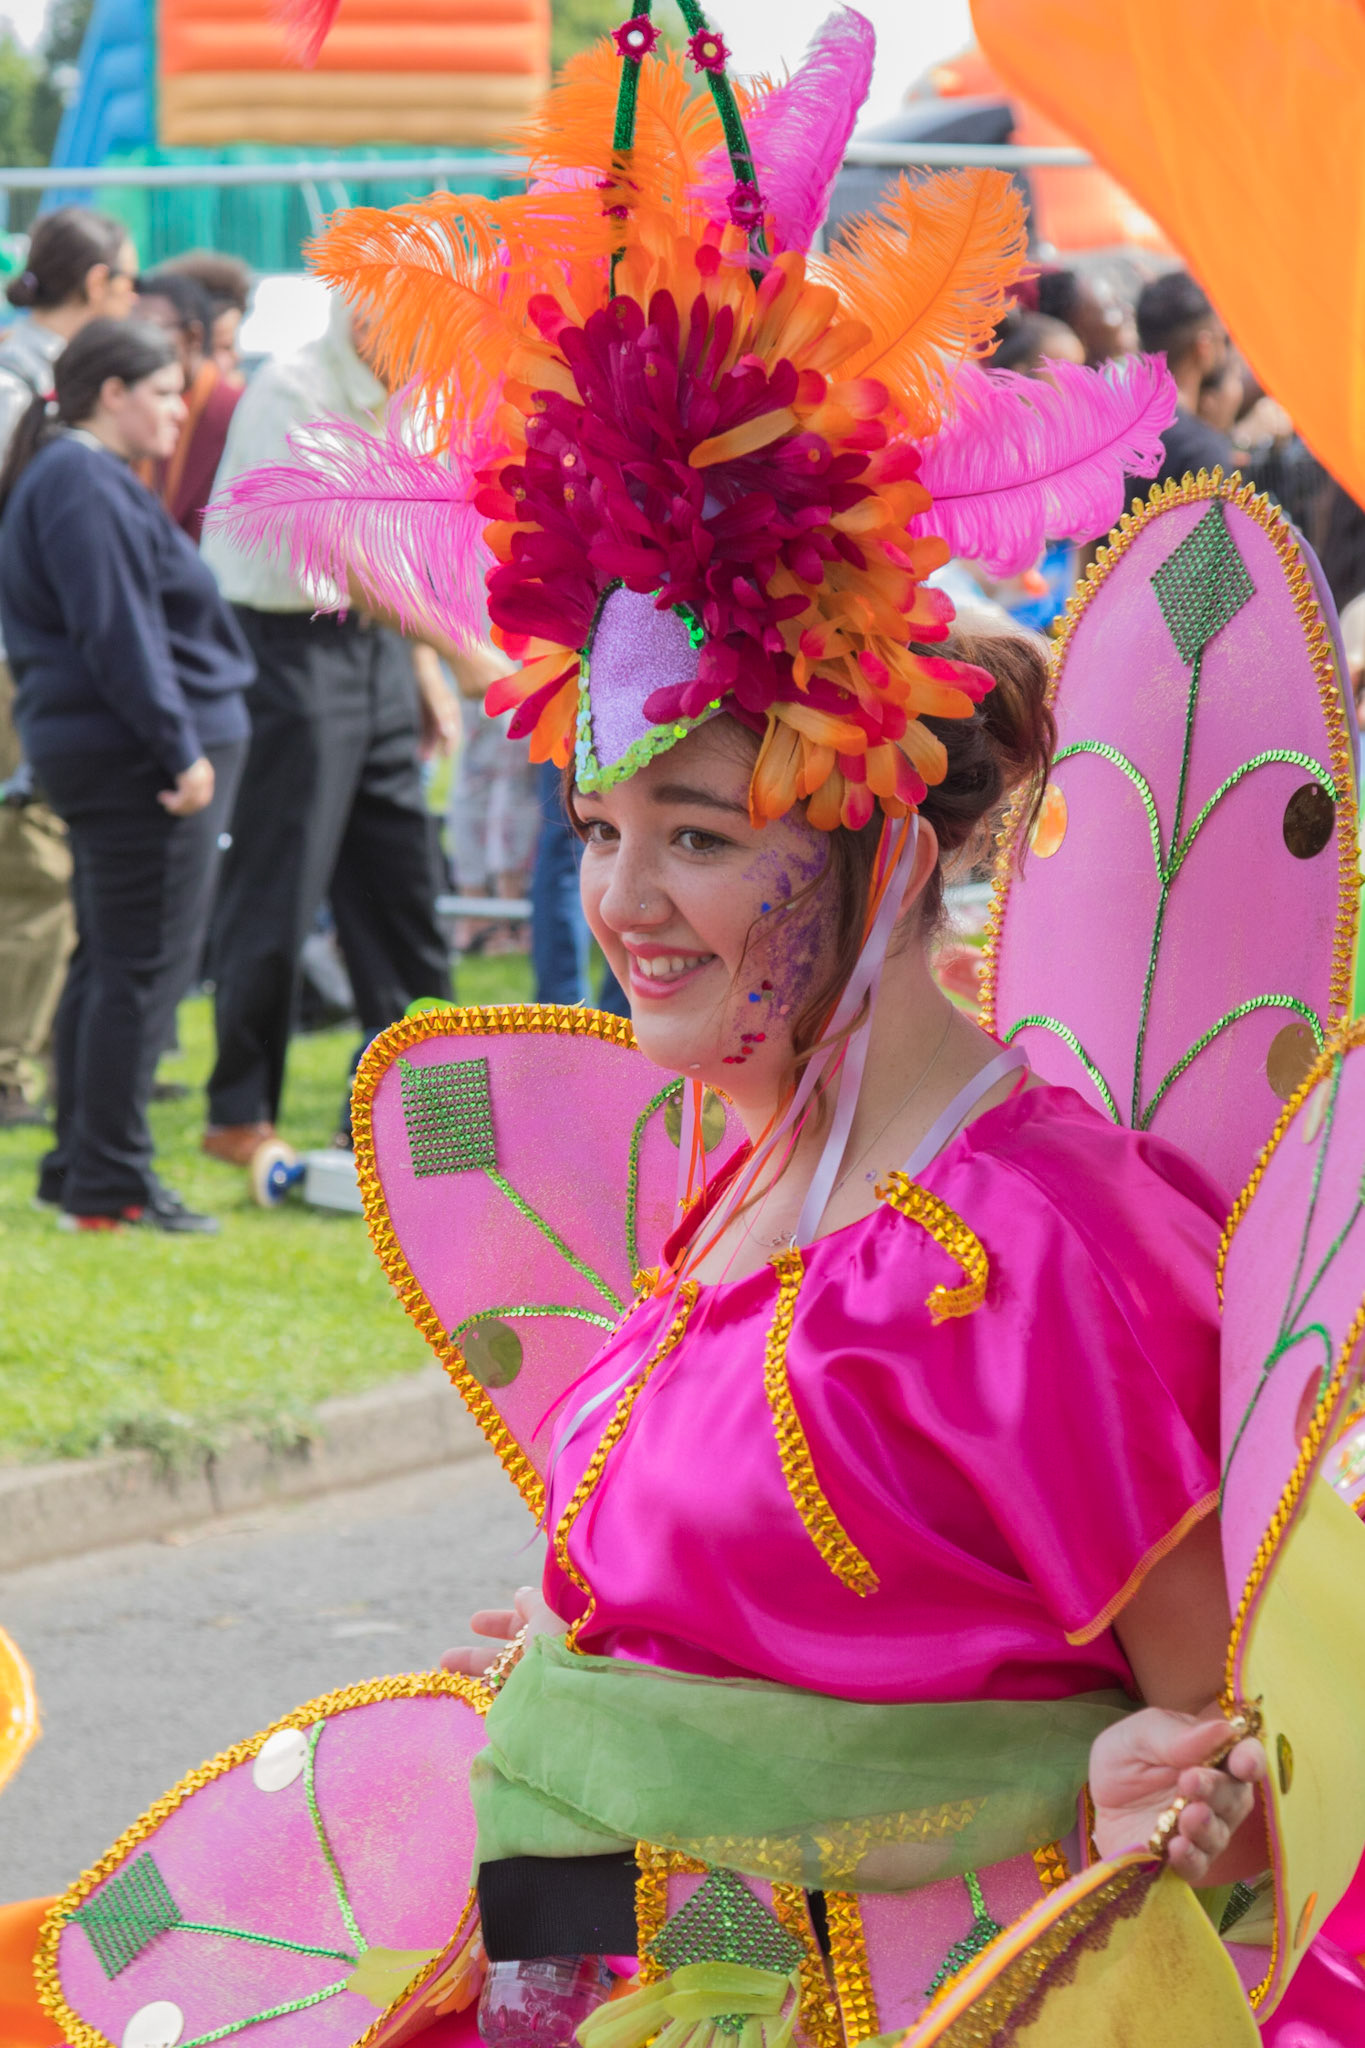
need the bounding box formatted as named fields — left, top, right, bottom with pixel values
left=160, top=0, right=548, bottom=78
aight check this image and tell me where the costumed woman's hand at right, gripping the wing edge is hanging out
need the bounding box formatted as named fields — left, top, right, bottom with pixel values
left=1091, top=1706, right=1267, bottom=1884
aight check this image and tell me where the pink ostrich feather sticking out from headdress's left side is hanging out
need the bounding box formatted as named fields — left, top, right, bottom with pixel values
left=209, top=406, right=493, bottom=647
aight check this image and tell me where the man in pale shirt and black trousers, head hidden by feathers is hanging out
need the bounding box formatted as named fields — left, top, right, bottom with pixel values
left=203, top=299, right=454, bottom=1165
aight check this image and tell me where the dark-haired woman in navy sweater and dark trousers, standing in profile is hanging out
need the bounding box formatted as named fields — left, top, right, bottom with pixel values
left=0, top=319, right=254, bottom=1233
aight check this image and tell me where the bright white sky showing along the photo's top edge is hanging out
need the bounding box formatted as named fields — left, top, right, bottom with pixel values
left=0, top=0, right=972, bottom=121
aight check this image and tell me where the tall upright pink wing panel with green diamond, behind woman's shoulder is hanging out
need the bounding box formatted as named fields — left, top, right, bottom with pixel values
left=982, top=477, right=1357, bottom=1196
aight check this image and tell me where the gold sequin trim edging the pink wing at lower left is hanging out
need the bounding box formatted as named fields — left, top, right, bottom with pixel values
left=33, top=1671, right=493, bottom=2048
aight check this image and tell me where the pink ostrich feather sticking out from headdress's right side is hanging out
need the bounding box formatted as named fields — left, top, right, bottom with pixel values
left=911, top=356, right=1175, bottom=575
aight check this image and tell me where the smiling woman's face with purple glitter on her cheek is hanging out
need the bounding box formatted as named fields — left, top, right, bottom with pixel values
left=573, top=717, right=837, bottom=1104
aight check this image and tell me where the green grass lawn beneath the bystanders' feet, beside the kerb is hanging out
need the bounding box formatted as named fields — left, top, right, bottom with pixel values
left=0, top=956, right=530, bottom=1460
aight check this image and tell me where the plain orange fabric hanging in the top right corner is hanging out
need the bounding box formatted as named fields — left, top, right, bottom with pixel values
left=972, top=0, right=1365, bottom=502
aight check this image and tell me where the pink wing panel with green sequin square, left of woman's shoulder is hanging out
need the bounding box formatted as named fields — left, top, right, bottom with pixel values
left=354, top=1008, right=749, bottom=1509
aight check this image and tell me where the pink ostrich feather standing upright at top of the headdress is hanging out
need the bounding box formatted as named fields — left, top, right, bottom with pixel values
left=696, top=6, right=876, bottom=250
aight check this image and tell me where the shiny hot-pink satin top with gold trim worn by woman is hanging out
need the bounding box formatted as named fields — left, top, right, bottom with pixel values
left=544, top=1087, right=1226, bottom=1702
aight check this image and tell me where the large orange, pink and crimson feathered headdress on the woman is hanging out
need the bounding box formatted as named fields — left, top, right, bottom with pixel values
left=218, top=0, right=1173, bottom=827
